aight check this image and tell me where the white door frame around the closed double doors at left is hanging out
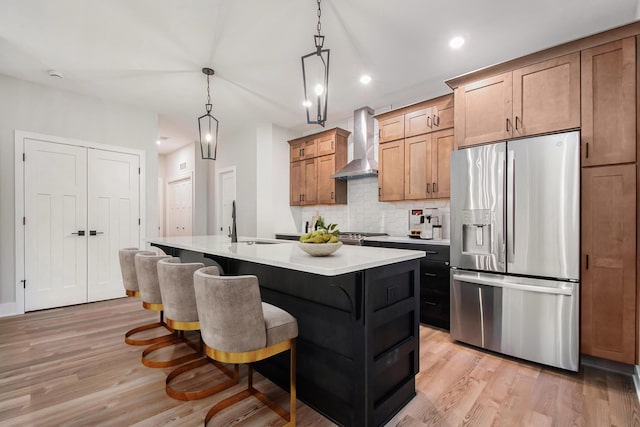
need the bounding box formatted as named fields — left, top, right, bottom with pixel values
left=11, top=129, right=146, bottom=317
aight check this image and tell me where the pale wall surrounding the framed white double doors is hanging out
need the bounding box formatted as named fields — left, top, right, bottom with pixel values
left=0, top=75, right=158, bottom=304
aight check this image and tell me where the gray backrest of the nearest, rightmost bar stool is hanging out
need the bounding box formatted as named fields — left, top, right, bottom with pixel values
left=193, top=267, right=267, bottom=353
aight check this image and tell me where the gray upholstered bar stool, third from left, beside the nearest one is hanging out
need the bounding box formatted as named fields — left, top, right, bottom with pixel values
left=153, top=258, right=239, bottom=400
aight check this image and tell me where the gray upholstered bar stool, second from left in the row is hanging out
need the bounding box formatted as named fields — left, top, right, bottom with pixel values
left=133, top=252, right=186, bottom=368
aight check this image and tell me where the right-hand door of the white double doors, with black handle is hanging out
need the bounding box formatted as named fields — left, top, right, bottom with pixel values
left=87, top=149, right=140, bottom=301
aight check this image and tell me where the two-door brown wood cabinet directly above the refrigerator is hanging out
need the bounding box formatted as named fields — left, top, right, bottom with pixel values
left=454, top=53, right=580, bottom=147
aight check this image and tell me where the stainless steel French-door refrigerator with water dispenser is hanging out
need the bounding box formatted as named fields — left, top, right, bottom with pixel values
left=451, top=131, right=580, bottom=371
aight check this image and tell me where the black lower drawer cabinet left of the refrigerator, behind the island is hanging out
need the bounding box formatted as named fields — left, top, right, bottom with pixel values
left=363, top=240, right=450, bottom=330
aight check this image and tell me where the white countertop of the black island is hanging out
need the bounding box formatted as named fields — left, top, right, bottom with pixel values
left=147, top=236, right=425, bottom=276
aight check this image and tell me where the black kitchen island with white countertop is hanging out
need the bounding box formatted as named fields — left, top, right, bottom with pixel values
left=148, top=236, right=425, bottom=426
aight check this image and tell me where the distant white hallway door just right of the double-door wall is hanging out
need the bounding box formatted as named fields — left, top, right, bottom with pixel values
left=167, top=176, right=193, bottom=236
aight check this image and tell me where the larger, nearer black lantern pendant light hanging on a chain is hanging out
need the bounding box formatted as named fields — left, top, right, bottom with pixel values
left=302, top=0, right=329, bottom=126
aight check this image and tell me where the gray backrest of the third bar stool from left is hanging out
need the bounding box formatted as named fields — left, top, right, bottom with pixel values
left=158, top=258, right=204, bottom=322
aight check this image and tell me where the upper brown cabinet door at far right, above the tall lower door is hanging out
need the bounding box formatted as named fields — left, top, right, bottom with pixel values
left=581, top=37, right=636, bottom=166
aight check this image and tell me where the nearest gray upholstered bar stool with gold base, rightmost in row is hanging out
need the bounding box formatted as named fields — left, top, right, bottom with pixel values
left=194, top=267, right=298, bottom=426
